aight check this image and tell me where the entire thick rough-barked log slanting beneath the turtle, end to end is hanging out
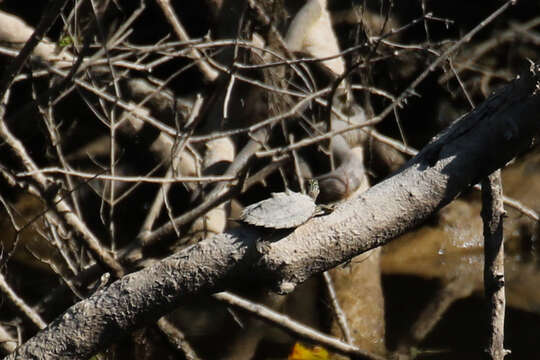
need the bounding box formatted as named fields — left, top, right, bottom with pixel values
left=7, top=68, right=540, bottom=359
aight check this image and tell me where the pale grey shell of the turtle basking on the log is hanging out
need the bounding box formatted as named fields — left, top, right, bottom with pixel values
left=241, top=191, right=316, bottom=229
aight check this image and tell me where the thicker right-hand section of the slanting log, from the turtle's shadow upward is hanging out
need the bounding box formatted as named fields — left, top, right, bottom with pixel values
left=260, top=69, right=540, bottom=292
